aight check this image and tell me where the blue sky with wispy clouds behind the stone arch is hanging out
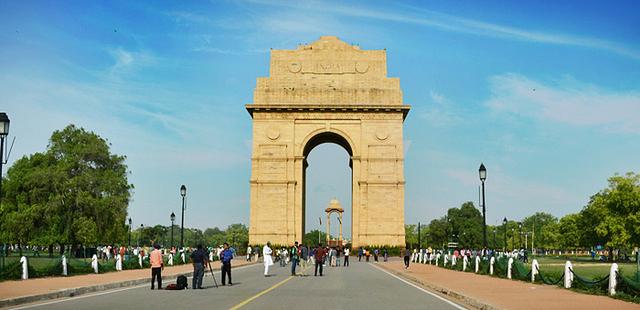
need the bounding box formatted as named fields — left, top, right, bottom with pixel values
left=0, top=1, right=640, bottom=234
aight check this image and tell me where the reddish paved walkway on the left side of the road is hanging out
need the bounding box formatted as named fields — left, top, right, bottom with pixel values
left=0, top=259, right=255, bottom=301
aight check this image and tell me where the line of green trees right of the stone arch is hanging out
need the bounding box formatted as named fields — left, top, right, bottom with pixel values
left=405, top=172, right=640, bottom=258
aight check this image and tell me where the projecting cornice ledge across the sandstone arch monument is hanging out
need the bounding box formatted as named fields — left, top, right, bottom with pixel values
left=245, top=104, right=411, bottom=120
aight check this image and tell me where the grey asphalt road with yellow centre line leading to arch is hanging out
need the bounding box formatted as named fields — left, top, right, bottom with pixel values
left=15, top=262, right=461, bottom=310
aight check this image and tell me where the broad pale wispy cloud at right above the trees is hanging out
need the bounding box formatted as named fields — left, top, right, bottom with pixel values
left=485, top=74, right=640, bottom=134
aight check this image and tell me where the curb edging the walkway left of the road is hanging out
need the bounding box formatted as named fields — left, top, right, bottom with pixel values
left=0, top=264, right=245, bottom=308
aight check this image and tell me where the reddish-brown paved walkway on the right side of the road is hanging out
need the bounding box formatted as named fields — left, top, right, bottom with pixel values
left=377, top=260, right=640, bottom=310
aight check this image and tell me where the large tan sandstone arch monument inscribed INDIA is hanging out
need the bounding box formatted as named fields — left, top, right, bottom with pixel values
left=246, top=36, right=410, bottom=247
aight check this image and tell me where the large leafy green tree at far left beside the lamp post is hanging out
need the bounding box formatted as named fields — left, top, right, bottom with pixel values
left=0, top=125, right=133, bottom=252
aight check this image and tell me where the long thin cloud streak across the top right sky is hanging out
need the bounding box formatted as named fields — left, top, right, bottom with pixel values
left=249, top=0, right=640, bottom=59
